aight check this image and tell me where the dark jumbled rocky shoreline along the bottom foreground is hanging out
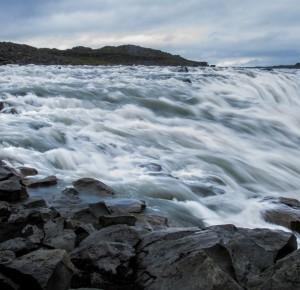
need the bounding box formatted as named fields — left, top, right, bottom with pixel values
left=0, top=161, right=300, bottom=290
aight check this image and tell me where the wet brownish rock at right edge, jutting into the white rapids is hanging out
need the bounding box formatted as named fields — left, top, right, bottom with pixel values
left=263, top=197, right=300, bottom=232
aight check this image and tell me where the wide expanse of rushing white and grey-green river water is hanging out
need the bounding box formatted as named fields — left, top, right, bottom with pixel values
left=0, top=66, right=300, bottom=231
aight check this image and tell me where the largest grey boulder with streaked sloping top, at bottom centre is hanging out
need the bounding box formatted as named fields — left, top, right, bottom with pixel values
left=137, top=229, right=243, bottom=290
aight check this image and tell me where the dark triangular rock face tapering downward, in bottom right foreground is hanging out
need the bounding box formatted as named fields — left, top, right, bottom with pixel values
left=209, top=225, right=297, bottom=287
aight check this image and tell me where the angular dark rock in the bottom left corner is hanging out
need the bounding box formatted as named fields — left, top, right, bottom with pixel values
left=0, top=250, right=75, bottom=290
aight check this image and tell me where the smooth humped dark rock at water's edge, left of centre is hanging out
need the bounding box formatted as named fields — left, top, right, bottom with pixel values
left=73, top=178, right=114, bottom=197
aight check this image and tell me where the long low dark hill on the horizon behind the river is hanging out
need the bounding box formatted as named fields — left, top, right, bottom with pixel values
left=0, top=42, right=208, bottom=66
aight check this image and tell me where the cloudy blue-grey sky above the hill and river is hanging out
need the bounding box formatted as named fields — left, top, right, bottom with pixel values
left=0, top=0, right=300, bottom=66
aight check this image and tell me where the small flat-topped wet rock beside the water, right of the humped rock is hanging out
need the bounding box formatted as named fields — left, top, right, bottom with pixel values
left=104, top=199, right=146, bottom=215
